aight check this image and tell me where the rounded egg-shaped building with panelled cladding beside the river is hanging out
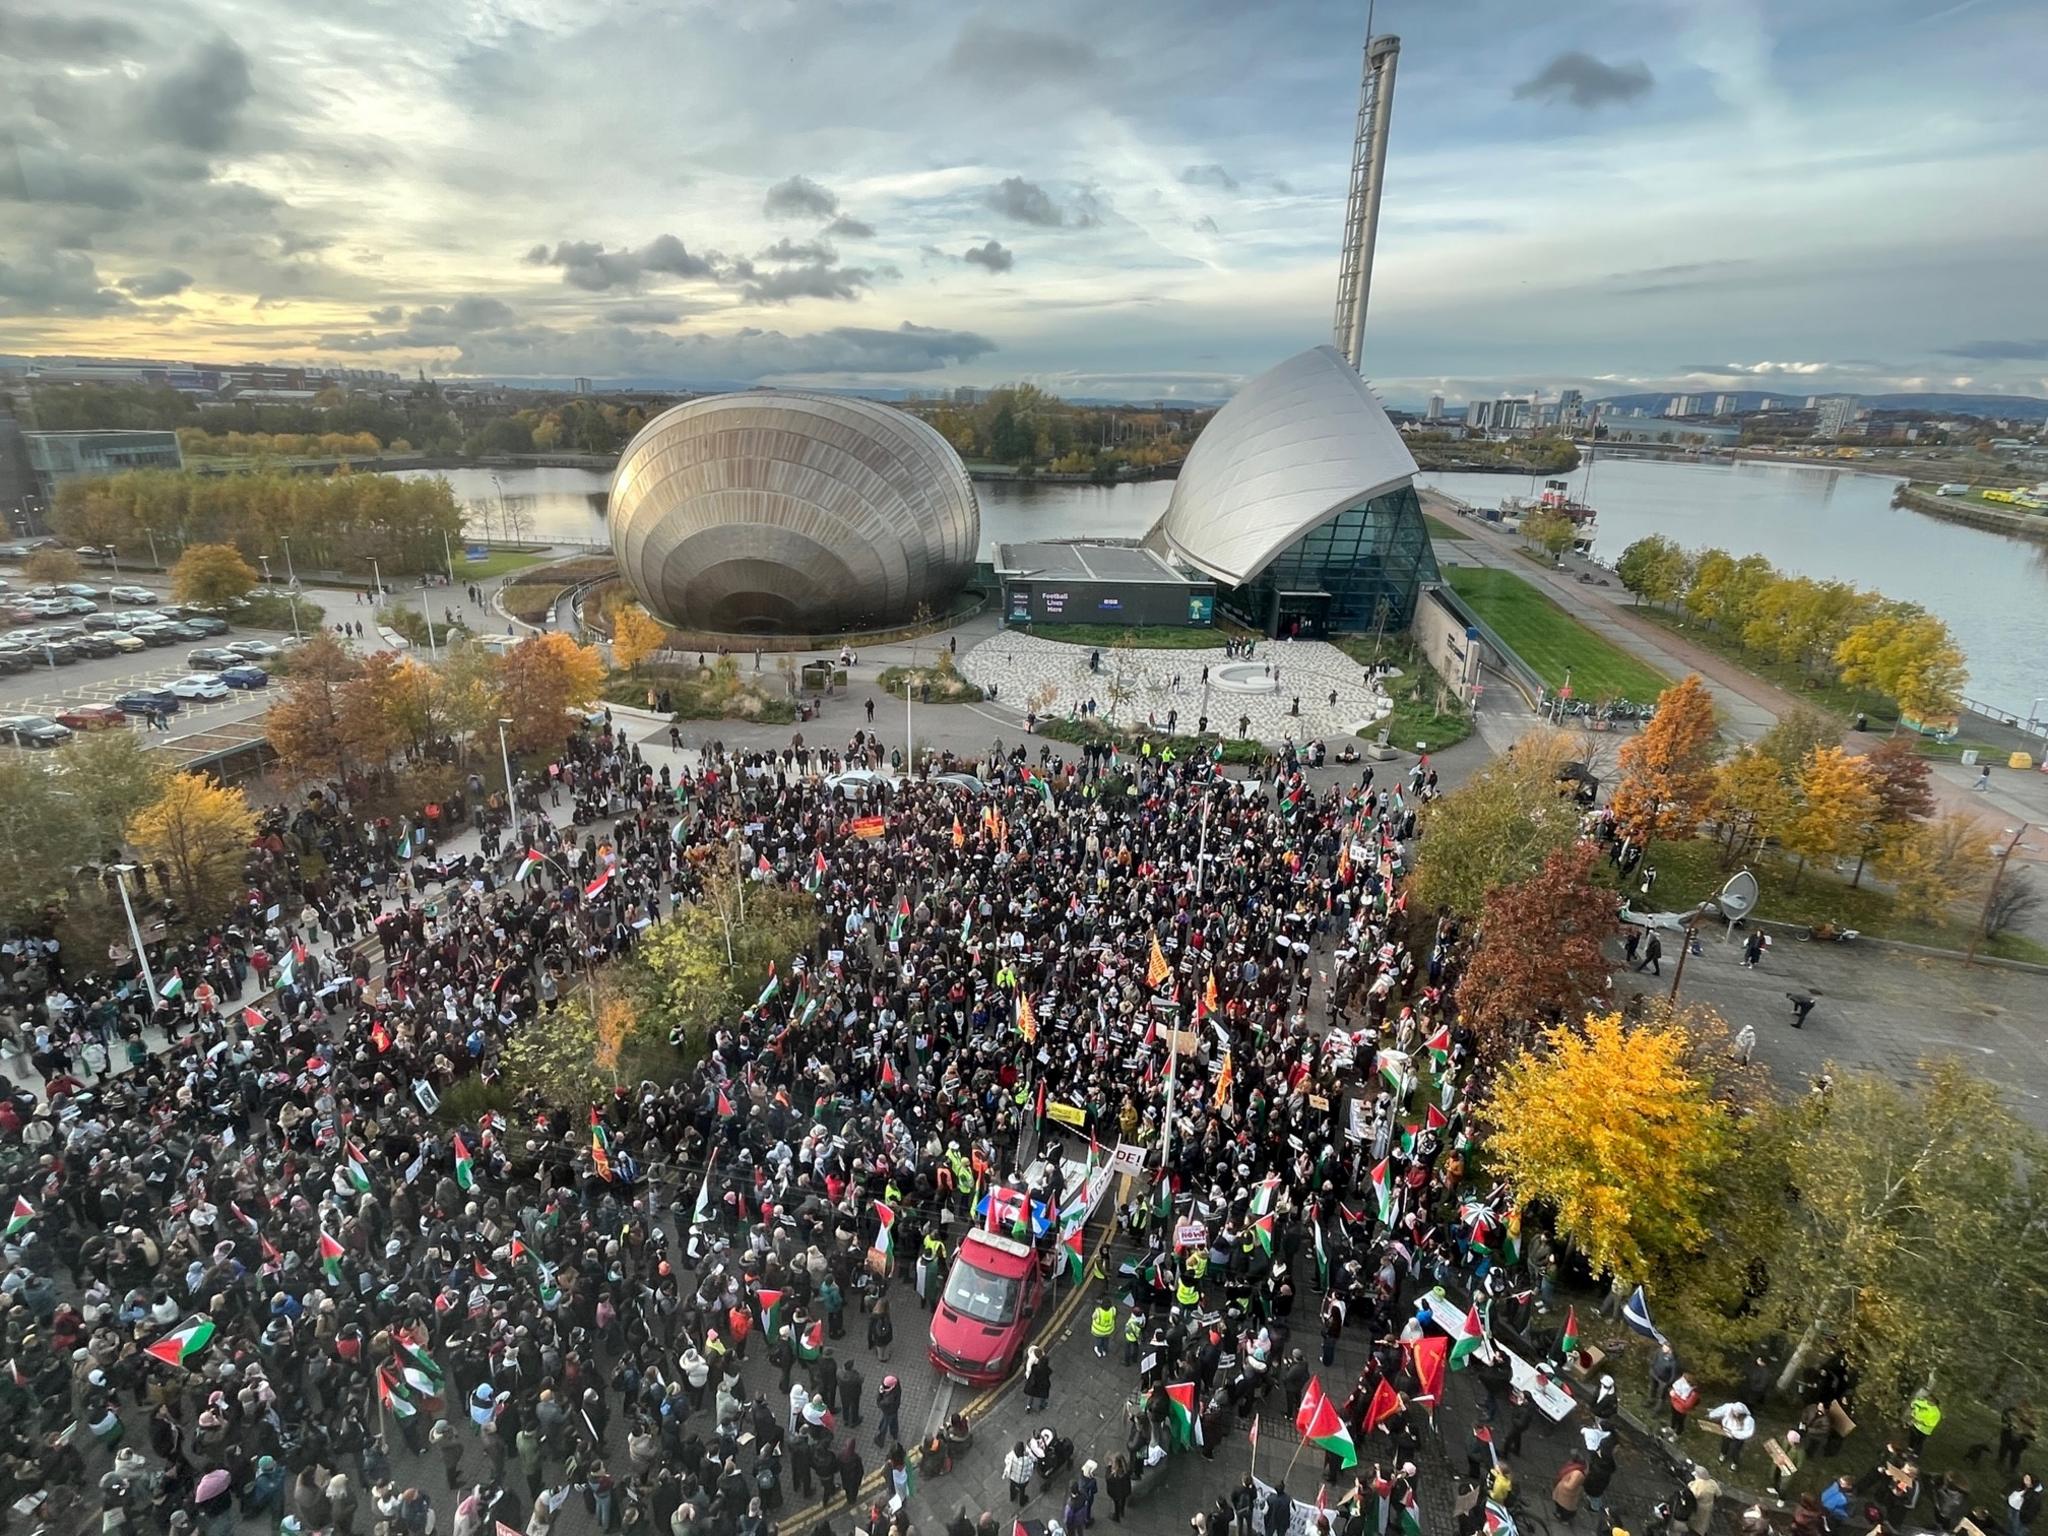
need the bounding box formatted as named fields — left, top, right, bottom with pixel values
left=610, top=399, right=981, bottom=635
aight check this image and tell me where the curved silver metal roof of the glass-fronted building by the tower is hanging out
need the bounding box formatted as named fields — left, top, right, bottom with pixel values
left=1145, top=346, right=1415, bottom=584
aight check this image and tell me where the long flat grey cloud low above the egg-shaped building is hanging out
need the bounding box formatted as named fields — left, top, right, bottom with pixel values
left=448, top=322, right=995, bottom=383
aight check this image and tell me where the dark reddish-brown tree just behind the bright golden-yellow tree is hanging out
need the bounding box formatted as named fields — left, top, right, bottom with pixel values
left=1458, top=840, right=1616, bottom=1057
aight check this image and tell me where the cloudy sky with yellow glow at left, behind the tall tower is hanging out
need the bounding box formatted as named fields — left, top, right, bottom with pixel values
left=0, top=0, right=2048, bottom=403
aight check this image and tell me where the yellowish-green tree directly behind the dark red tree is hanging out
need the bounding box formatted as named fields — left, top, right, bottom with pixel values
left=1413, top=731, right=1579, bottom=913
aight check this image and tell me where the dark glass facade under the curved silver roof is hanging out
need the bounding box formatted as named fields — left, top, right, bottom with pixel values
left=1219, top=485, right=1438, bottom=639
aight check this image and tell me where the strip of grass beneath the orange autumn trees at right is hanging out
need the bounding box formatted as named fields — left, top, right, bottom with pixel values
left=1602, top=838, right=2048, bottom=965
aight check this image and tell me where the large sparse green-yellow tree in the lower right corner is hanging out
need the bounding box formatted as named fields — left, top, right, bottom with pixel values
left=1772, top=1059, right=2048, bottom=1417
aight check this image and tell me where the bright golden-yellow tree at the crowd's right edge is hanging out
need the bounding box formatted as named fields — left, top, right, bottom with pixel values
left=1477, top=1014, right=1735, bottom=1286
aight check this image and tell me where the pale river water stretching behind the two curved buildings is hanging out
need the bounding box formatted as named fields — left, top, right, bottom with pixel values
left=412, top=459, right=2048, bottom=717
